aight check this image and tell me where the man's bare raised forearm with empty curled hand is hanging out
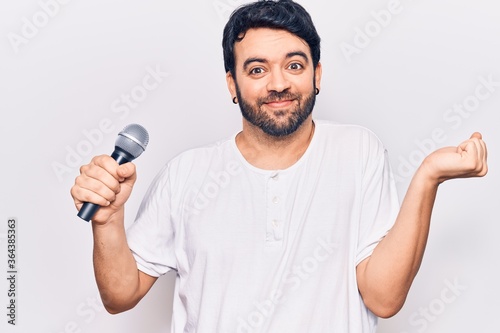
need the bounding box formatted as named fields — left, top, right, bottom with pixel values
left=356, top=133, right=488, bottom=318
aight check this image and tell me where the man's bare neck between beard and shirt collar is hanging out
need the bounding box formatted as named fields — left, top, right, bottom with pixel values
left=236, top=115, right=314, bottom=170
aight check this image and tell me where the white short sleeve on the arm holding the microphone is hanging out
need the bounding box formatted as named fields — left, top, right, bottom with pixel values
left=127, top=165, right=176, bottom=277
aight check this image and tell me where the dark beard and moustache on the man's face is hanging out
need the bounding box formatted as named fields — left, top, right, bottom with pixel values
left=236, top=83, right=316, bottom=138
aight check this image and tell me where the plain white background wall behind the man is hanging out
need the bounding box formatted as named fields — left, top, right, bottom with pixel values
left=0, top=0, right=500, bottom=333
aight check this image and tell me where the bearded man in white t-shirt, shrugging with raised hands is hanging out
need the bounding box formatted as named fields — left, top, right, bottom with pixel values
left=71, top=0, right=487, bottom=333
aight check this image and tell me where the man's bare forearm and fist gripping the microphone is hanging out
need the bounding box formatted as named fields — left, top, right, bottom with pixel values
left=71, top=155, right=156, bottom=313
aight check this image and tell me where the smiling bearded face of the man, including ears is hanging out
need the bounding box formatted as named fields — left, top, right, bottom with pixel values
left=227, top=28, right=321, bottom=137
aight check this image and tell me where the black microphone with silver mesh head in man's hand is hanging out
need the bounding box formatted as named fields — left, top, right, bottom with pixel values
left=78, top=124, right=149, bottom=222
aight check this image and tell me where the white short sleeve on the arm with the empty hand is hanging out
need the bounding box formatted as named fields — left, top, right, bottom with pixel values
left=356, top=133, right=399, bottom=265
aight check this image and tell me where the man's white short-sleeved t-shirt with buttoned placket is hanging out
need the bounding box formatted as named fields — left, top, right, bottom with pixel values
left=127, top=120, right=399, bottom=333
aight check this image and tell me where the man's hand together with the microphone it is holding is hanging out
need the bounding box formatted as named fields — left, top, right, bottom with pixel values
left=71, top=124, right=149, bottom=223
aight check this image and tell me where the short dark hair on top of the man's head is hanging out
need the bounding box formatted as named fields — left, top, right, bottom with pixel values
left=222, top=0, right=321, bottom=76
